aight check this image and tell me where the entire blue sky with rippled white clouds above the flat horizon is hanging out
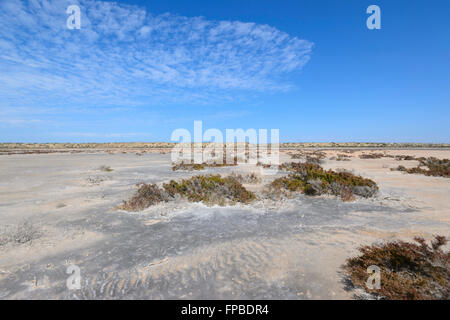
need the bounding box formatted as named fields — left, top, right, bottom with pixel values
left=0, top=0, right=450, bottom=143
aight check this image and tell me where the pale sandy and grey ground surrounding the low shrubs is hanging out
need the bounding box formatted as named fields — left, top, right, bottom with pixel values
left=0, top=150, right=450, bottom=299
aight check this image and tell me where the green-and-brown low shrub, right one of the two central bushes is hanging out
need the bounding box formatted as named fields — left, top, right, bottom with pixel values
left=271, top=162, right=378, bottom=201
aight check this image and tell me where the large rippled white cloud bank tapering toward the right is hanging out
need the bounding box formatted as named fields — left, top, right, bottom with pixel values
left=0, top=0, right=312, bottom=108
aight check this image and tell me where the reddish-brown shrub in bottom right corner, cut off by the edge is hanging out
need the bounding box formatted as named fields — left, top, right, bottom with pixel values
left=344, top=236, right=450, bottom=300
